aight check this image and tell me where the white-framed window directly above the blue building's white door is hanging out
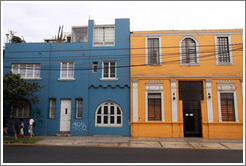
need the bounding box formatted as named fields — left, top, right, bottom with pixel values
left=60, top=62, right=74, bottom=79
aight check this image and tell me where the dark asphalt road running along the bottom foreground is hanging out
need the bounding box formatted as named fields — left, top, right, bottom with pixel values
left=3, top=145, right=243, bottom=163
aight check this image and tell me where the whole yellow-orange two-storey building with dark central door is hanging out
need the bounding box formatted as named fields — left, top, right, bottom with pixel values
left=130, top=29, right=243, bottom=139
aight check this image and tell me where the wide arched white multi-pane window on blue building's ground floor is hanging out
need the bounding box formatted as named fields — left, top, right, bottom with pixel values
left=95, top=102, right=123, bottom=127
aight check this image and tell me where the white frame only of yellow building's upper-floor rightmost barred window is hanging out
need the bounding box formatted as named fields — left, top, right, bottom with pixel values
left=214, top=34, right=233, bottom=65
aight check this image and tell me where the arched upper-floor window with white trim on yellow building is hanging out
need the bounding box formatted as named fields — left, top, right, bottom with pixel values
left=180, top=37, right=199, bottom=65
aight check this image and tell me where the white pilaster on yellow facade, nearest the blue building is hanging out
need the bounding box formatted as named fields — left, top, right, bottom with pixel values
left=132, top=80, right=138, bottom=122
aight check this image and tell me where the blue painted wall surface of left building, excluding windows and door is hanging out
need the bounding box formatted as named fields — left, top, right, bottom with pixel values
left=3, top=19, right=130, bottom=135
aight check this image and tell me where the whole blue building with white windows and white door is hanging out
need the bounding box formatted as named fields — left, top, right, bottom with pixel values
left=3, top=19, right=130, bottom=136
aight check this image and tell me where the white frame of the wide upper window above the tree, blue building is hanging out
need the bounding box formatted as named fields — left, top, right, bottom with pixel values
left=11, top=63, right=41, bottom=80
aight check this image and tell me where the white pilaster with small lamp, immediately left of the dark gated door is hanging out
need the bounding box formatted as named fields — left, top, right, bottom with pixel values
left=171, top=79, right=178, bottom=122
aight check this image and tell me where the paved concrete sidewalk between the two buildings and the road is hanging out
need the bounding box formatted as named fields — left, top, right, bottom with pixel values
left=35, top=136, right=243, bottom=150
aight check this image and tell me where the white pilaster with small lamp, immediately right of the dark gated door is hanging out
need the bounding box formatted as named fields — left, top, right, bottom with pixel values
left=206, top=79, right=214, bottom=123
